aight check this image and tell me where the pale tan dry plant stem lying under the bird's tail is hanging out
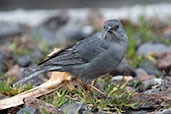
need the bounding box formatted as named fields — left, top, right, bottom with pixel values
left=0, top=72, right=71, bottom=110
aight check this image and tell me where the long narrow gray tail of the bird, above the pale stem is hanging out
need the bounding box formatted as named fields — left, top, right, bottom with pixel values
left=12, top=65, right=61, bottom=87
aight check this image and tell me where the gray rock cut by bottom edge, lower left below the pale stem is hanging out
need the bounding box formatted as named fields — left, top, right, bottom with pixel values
left=16, top=107, right=37, bottom=114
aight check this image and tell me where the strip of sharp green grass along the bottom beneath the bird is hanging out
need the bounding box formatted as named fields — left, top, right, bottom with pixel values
left=38, top=77, right=137, bottom=113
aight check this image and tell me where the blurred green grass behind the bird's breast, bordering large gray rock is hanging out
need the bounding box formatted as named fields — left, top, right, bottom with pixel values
left=124, top=14, right=171, bottom=68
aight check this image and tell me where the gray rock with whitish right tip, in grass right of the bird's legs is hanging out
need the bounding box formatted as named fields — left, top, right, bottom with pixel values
left=139, top=78, right=162, bottom=92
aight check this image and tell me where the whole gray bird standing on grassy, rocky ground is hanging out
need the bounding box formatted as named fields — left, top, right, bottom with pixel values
left=15, top=20, right=128, bottom=85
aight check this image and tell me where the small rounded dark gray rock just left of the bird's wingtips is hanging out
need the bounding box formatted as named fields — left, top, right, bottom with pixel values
left=18, top=55, right=32, bottom=67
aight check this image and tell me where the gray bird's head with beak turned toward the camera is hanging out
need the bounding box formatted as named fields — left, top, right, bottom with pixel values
left=104, top=20, right=128, bottom=41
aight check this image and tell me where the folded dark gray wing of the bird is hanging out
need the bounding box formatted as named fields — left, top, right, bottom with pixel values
left=39, top=37, right=109, bottom=66
